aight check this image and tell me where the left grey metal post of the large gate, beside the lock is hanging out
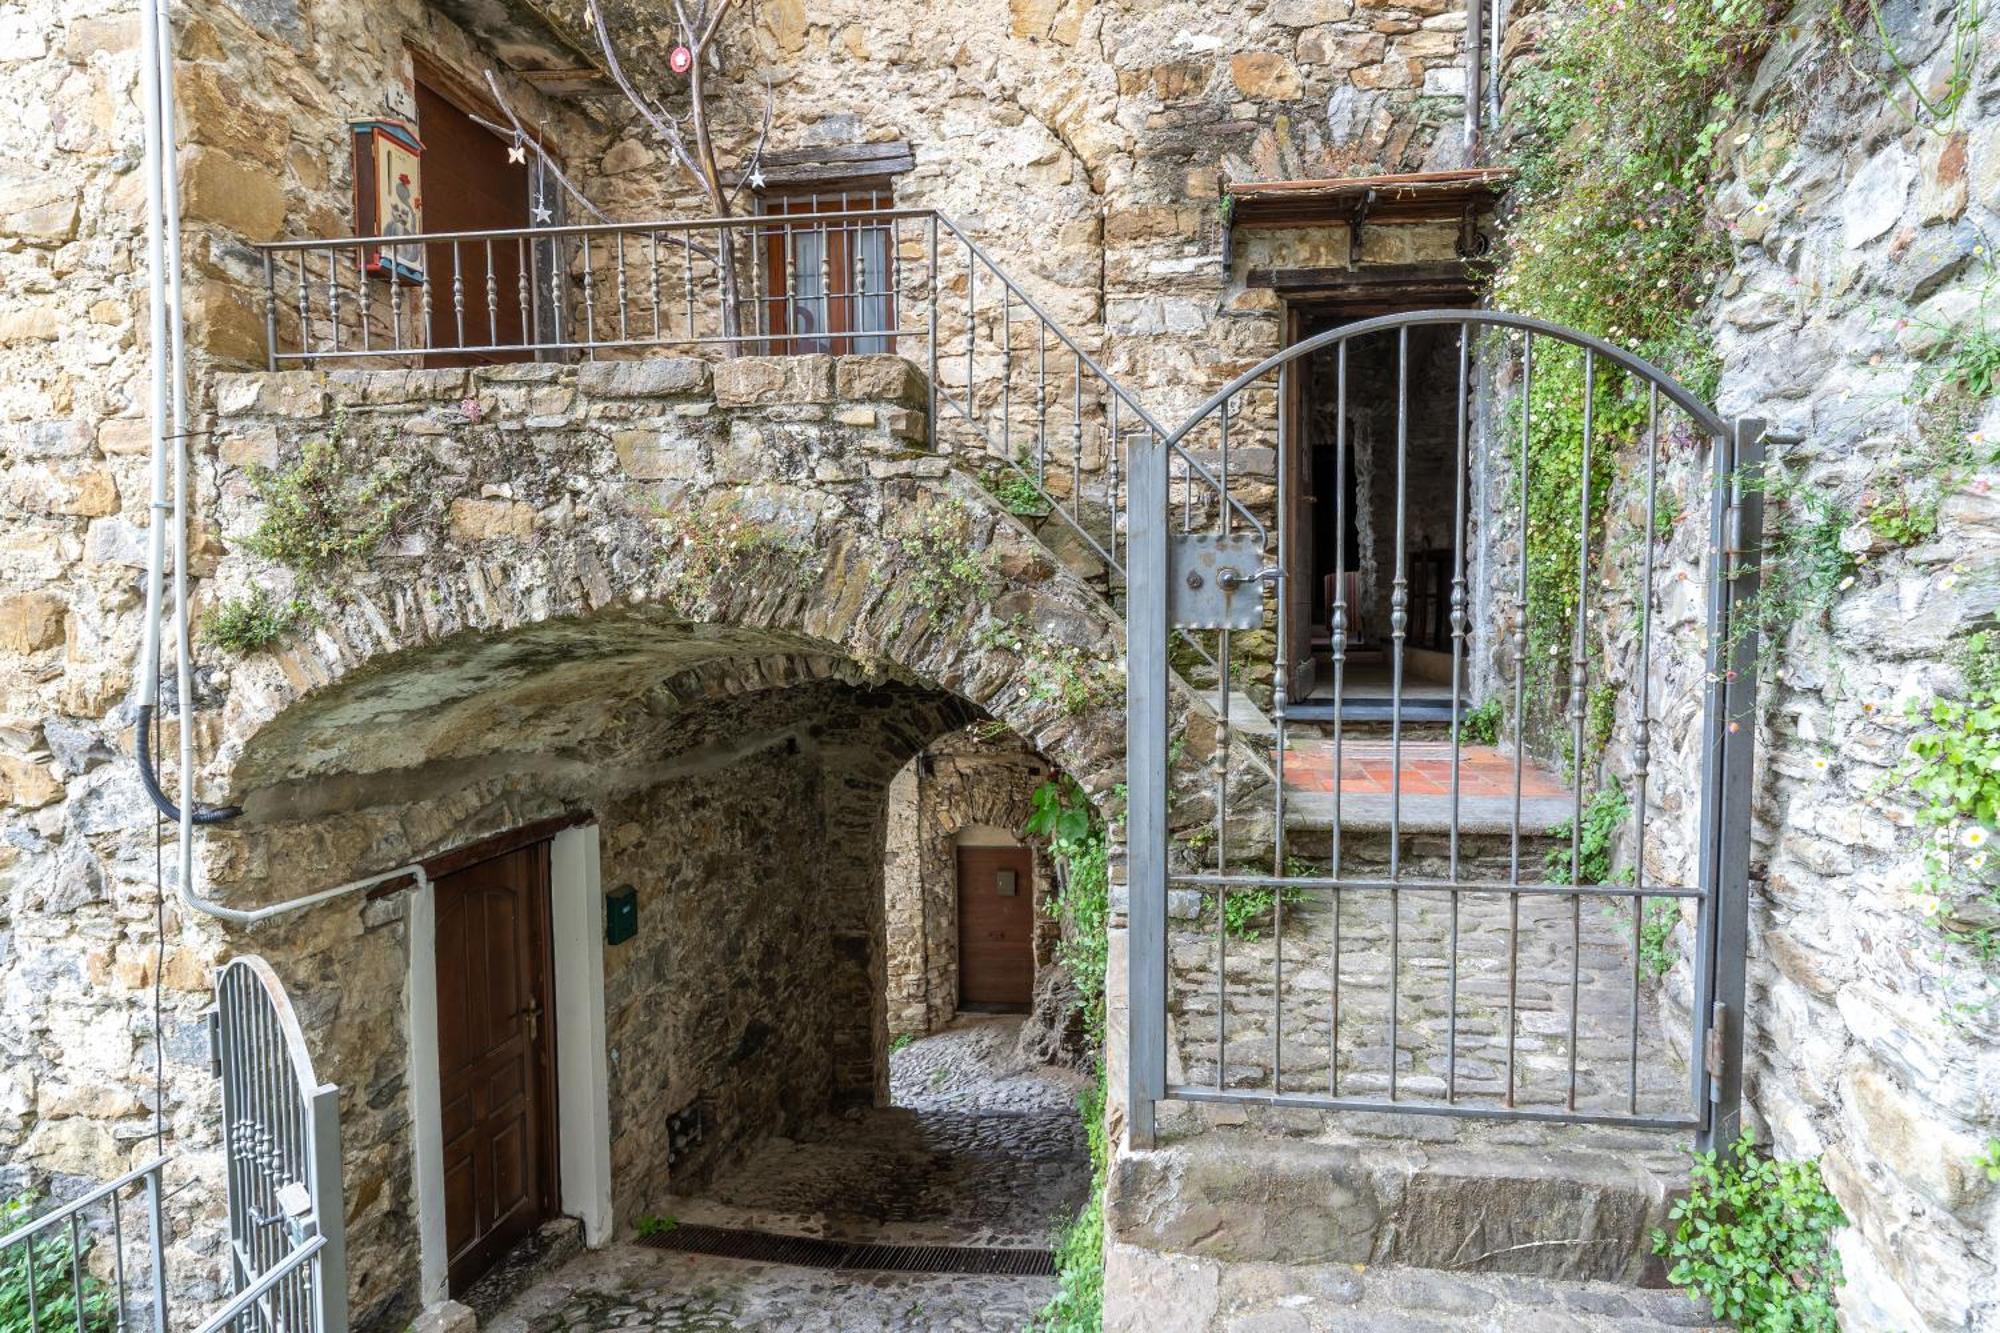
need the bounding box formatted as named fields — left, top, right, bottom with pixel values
left=1126, top=432, right=1168, bottom=1149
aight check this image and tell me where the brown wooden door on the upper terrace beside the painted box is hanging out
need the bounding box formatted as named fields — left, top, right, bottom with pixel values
left=416, top=78, right=534, bottom=366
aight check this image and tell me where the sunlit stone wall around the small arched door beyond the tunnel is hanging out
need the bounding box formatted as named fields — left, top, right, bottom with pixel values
left=886, top=731, right=1060, bottom=1037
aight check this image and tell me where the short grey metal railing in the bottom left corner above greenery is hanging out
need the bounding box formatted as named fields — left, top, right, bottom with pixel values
left=0, top=1157, right=166, bottom=1333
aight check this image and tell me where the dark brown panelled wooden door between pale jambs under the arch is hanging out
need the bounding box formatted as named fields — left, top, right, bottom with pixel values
left=436, top=843, right=556, bottom=1293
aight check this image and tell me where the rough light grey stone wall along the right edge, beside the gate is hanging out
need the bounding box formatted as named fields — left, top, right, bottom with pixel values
left=1688, top=4, right=2000, bottom=1329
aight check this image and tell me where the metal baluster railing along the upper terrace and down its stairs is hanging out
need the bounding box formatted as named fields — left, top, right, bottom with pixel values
left=260, top=208, right=1260, bottom=582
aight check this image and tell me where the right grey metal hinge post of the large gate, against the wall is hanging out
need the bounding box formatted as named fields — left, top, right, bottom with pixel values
left=1696, top=418, right=1764, bottom=1153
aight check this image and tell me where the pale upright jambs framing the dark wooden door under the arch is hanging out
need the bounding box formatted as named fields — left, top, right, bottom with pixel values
left=404, top=821, right=614, bottom=1307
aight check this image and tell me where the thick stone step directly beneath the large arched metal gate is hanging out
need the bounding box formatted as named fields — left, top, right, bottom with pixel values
left=1106, top=1103, right=1686, bottom=1287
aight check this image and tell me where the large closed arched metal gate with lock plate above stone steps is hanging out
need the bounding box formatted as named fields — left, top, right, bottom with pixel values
left=1126, top=310, right=1764, bottom=1145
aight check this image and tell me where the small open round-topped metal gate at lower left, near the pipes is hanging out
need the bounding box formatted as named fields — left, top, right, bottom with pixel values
left=208, top=957, right=348, bottom=1333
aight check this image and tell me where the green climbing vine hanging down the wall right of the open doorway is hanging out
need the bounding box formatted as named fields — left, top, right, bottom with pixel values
left=1494, top=0, right=1784, bottom=740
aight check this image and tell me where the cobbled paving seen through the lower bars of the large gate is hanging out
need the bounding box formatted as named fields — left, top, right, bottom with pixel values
left=1170, top=872, right=1688, bottom=1115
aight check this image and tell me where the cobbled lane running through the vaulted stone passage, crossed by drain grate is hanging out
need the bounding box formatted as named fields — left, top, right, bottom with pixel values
left=488, top=1015, right=1090, bottom=1333
